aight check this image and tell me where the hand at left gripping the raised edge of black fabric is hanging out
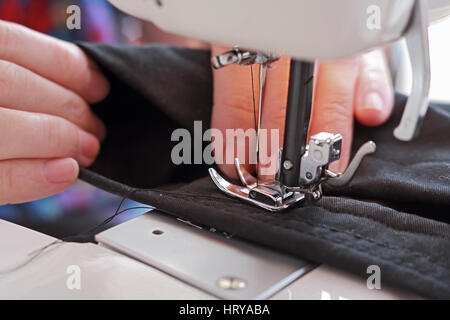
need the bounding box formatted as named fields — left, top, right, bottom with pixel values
left=0, top=21, right=109, bottom=205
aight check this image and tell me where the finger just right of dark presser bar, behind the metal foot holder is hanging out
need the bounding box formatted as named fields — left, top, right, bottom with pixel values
left=310, top=57, right=360, bottom=172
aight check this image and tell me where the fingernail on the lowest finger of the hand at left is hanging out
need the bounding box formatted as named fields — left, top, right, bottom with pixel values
left=44, top=158, right=78, bottom=183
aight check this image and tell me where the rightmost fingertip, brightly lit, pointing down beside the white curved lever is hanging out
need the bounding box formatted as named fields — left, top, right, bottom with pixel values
left=355, top=50, right=394, bottom=126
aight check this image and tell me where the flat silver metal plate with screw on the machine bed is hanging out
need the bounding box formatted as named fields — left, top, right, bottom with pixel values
left=96, top=213, right=314, bottom=299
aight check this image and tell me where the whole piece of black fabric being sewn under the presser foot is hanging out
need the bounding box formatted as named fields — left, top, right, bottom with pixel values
left=80, top=44, right=450, bottom=299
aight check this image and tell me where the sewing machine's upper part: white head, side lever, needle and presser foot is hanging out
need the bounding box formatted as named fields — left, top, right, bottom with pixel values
left=110, top=0, right=450, bottom=211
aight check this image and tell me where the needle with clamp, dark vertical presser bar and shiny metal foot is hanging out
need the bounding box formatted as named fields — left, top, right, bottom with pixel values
left=209, top=47, right=376, bottom=211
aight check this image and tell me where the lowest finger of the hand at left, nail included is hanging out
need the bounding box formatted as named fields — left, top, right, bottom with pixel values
left=0, top=158, right=79, bottom=205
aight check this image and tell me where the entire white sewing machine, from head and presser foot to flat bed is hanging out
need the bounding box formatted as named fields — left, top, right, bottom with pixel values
left=0, top=0, right=450, bottom=299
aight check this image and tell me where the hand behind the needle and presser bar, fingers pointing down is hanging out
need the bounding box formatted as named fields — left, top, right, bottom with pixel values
left=212, top=46, right=394, bottom=180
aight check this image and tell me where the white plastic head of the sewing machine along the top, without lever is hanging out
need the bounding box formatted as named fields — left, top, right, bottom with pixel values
left=109, top=0, right=450, bottom=60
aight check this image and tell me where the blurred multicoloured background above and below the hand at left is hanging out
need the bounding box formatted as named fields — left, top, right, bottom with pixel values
left=0, top=0, right=156, bottom=238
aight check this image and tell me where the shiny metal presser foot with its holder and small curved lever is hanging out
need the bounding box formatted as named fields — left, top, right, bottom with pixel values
left=209, top=132, right=376, bottom=212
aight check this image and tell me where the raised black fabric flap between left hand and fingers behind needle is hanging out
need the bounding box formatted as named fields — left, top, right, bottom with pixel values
left=79, top=43, right=212, bottom=188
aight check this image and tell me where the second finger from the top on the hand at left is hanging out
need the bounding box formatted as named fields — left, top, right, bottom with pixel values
left=0, top=60, right=105, bottom=140
